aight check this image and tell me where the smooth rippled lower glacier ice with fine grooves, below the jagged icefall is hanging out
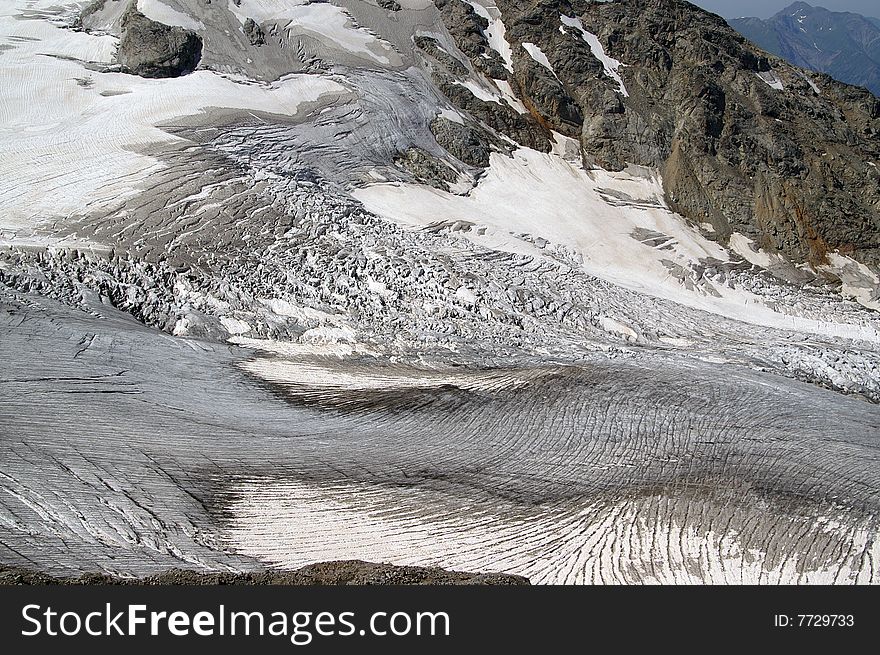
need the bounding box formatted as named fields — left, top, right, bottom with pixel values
left=0, top=292, right=880, bottom=583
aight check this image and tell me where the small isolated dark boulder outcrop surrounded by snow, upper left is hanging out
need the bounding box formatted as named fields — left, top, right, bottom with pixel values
left=116, top=2, right=202, bottom=77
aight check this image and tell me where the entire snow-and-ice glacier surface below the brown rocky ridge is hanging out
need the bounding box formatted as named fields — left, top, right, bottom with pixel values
left=0, top=0, right=880, bottom=583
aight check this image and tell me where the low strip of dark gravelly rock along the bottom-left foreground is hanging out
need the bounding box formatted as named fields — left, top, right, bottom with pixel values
left=0, top=560, right=529, bottom=586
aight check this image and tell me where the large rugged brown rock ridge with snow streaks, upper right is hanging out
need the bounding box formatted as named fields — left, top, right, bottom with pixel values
left=437, top=0, right=880, bottom=264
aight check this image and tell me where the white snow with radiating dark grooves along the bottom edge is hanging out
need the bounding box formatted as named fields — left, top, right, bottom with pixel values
left=228, top=478, right=880, bottom=584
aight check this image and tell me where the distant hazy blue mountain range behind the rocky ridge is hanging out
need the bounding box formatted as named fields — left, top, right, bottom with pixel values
left=728, top=2, right=880, bottom=95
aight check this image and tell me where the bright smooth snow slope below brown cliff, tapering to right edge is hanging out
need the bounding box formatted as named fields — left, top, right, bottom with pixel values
left=354, top=148, right=880, bottom=341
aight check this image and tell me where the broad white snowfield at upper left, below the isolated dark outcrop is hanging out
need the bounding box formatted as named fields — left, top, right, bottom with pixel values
left=0, top=2, right=346, bottom=229
